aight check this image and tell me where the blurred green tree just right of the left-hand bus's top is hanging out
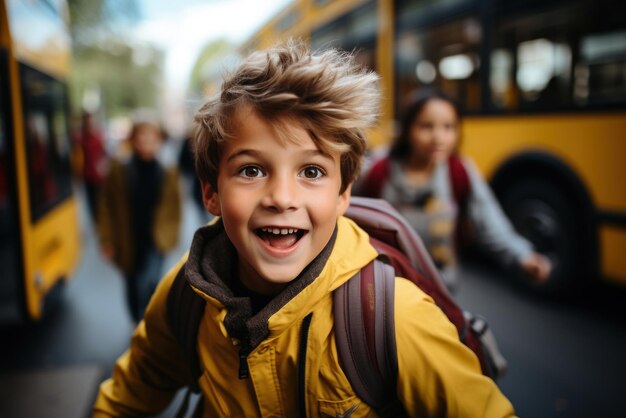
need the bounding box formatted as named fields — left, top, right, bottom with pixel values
left=68, top=0, right=164, bottom=118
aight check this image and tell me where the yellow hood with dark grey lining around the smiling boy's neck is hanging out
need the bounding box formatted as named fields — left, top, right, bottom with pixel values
left=185, top=217, right=376, bottom=350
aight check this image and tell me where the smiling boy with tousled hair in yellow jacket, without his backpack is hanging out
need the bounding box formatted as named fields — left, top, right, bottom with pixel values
left=94, top=43, right=513, bottom=418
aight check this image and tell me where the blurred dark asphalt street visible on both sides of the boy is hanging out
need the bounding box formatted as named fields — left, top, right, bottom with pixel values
left=0, top=187, right=626, bottom=418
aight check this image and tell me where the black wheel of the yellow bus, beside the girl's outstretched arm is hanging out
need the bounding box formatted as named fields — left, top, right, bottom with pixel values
left=500, top=178, right=591, bottom=294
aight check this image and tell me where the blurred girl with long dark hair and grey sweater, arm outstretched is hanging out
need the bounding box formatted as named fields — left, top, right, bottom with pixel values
left=355, top=91, right=552, bottom=289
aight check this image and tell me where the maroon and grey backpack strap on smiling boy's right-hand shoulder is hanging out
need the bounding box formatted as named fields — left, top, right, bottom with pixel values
left=334, top=260, right=406, bottom=417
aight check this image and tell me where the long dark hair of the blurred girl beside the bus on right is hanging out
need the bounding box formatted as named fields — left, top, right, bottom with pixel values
left=389, top=89, right=461, bottom=161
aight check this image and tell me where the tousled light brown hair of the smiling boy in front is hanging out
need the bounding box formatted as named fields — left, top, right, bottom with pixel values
left=194, top=40, right=380, bottom=192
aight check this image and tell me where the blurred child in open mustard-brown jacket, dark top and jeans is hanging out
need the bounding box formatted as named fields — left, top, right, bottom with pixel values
left=98, top=120, right=182, bottom=322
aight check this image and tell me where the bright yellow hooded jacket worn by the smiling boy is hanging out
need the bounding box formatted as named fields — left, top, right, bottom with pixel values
left=94, top=217, right=514, bottom=418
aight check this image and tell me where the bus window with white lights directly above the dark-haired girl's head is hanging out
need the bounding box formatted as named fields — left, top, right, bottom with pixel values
left=396, top=17, right=482, bottom=113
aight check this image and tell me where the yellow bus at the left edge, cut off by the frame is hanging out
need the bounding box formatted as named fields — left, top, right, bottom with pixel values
left=0, top=0, right=80, bottom=322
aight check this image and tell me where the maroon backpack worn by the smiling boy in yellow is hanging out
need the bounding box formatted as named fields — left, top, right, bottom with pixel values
left=167, top=196, right=506, bottom=417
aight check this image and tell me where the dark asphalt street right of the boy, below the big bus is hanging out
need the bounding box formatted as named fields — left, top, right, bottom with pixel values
left=457, top=258, right=626, bottom=418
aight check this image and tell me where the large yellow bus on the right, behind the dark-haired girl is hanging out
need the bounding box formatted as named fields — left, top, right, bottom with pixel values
left=243, top=0, right=626, bottom=291
